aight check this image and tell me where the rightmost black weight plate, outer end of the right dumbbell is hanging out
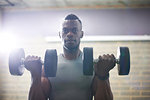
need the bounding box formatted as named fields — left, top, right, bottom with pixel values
left=118, top=47, right=130, bottom=75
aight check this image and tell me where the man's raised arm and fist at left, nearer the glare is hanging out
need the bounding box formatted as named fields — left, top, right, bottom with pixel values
left=24, top=56, right=51, bottom=100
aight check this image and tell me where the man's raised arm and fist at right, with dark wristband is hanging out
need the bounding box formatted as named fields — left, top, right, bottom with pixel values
left=92, top=54, right=115, bottom=100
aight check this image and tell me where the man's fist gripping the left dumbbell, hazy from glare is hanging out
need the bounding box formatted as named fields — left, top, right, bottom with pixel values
left=24, top=56, right=42, bottom=78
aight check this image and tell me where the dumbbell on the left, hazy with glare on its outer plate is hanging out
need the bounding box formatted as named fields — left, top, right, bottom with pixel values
left=9, top=48, right=57, bottom=77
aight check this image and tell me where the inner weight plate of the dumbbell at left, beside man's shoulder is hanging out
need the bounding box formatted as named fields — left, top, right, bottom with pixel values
left=44, top=49, right=57, bottom=77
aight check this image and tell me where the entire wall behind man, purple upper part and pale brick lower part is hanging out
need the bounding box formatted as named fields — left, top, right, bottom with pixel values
left=0, top=9, right=150, bottom=100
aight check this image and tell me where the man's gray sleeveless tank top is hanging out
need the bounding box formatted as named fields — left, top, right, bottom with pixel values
left=49, top=53, right=93, bottom=100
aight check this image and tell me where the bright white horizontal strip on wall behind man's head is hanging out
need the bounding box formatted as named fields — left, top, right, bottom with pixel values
left=45, top=35, right=150, bottom=42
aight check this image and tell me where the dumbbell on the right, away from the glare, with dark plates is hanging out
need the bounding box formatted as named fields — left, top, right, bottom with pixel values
left=83, top=47, right=130, bottom=75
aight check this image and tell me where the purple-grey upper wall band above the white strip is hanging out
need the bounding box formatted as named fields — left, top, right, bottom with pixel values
left=4, top=8, right=150, bottom=36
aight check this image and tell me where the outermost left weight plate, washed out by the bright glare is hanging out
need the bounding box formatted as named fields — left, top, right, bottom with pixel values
left=9, top=48, right=25, bottom=76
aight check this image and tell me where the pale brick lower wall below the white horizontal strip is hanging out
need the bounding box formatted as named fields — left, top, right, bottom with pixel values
left=0, top=38, right=150, bottom=100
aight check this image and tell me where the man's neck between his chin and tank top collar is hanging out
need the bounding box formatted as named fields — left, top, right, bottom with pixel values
left=63, top=47, right=81, bottom=60
